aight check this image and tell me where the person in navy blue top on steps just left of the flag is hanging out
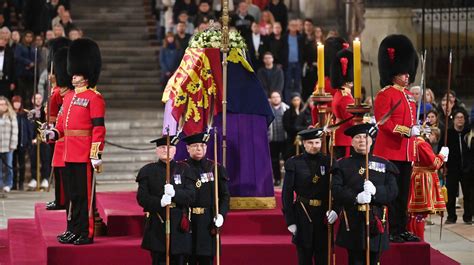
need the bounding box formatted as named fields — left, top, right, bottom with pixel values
left=160, top=32, right=182, bottom=86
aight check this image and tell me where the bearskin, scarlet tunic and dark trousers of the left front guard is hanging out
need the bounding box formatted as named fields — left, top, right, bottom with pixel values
left=51, top=39, right=105, bottom=245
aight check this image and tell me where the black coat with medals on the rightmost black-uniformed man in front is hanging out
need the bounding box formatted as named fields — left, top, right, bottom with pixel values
left=332, top=153, right=399, bottom=251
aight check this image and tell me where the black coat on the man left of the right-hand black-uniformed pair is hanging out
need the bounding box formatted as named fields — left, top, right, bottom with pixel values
left=282, top=153, right=330, bottom=249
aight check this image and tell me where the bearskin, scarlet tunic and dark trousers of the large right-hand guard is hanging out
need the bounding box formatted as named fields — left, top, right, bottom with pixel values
left=373, top=35, right=418, bottom=242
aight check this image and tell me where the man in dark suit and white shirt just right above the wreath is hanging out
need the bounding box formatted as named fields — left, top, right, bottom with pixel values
left=246, top=22, right=268, bottom=69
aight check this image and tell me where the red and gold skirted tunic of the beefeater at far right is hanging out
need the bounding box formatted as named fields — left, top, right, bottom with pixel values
left=408, top=137, right=446, bottom=213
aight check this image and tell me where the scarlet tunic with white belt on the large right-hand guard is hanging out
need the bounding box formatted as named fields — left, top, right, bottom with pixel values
left=374, top=86, right=416, bottom=161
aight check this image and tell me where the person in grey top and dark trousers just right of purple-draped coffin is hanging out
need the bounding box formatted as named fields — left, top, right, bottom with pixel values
left=268, top=91, right=289, bottom=186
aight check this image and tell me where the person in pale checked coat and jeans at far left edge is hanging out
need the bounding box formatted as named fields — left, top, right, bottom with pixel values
left=0, top=96, right=18, bottom=192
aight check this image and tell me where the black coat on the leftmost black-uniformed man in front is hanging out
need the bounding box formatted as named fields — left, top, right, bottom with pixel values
left=136, top=161, right=195, bottom=255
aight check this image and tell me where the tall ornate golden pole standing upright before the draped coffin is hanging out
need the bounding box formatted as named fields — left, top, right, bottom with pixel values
left=221, top=0, right=229, bottom=166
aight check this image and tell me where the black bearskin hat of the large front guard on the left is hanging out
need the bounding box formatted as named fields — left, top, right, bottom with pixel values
left=67, top=38, right=102, bottom=88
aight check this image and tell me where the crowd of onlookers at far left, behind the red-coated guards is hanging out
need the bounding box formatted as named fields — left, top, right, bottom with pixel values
left=0, top=0, right=83, bottom=192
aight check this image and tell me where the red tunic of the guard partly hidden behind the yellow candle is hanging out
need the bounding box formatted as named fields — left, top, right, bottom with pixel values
left=332, top=89, right=354, bottom=146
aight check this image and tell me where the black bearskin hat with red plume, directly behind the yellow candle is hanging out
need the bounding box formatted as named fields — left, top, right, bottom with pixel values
left=331, top=49, right=354, bottom=88
